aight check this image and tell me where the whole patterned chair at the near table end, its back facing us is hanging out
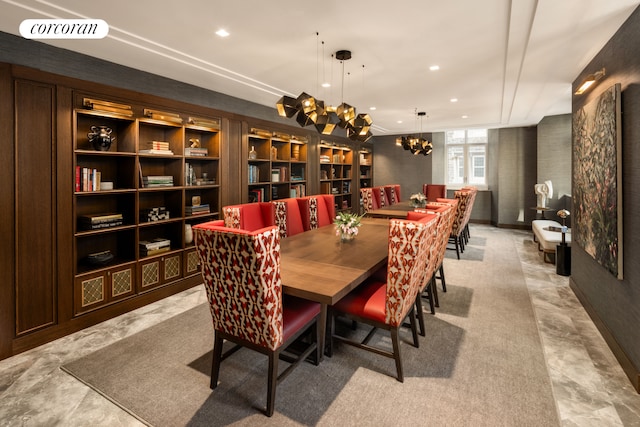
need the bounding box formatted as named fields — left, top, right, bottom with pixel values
left=193, top=224, right=320, bottom=416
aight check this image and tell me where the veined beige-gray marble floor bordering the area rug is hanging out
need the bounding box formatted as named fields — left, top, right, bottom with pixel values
left=0, top=225, right=640, bottom=427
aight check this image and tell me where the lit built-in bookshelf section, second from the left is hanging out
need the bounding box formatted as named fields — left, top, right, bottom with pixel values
left=247, top=128, right=308, bottom=202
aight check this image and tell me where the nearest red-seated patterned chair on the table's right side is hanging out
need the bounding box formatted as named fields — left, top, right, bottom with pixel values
left=329, top=219, right=435, bottom=382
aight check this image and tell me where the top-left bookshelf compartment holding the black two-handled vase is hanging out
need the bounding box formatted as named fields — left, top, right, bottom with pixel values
left=75, top=110, right=136, bottom=153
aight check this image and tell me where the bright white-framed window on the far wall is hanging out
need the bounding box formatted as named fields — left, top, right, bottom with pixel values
left=445, top=129, right=488, bottom=188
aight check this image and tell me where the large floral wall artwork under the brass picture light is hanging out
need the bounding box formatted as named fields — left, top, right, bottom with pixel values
left=572, top=84, right=622, bottom=279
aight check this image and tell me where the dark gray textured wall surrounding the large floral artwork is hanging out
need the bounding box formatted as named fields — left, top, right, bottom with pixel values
left=571, top=4, right=640, bottom=386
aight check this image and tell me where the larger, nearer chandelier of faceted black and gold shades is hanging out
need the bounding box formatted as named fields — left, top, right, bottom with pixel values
left=276, top=50, right=373, bottom=142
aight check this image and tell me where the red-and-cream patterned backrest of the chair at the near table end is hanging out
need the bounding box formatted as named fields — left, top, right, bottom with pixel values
left=193, top=223, right=283, bottom=350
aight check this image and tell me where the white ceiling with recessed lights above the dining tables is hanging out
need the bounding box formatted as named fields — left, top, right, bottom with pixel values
left=0, top=0, right=640, bottom=135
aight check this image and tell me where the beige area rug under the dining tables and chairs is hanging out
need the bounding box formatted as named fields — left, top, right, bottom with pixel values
left=63, top=227, right=559, bottom=426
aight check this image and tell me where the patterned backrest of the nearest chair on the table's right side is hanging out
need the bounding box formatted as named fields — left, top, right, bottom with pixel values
left=385, top=216, right=437, bottom=326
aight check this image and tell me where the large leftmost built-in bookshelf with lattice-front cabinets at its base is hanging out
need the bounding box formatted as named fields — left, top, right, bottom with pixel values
left=73, top=102, right=220, bottom=315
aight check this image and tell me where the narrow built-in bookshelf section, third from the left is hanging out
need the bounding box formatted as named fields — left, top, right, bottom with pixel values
left=318, top=141, right=354, bottom=211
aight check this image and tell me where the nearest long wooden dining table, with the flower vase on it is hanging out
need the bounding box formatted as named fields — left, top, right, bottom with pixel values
left=280, top=218, right=389, bottom=360
